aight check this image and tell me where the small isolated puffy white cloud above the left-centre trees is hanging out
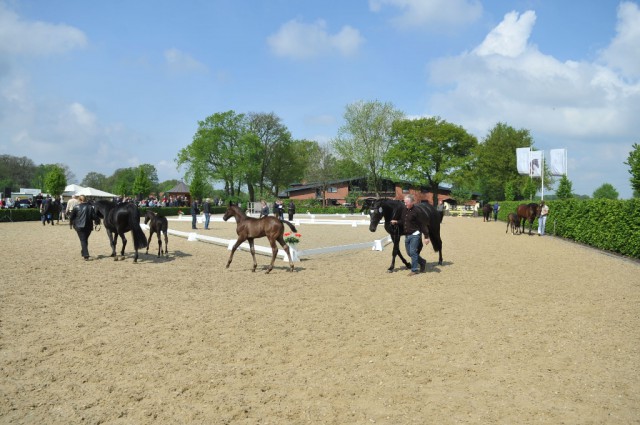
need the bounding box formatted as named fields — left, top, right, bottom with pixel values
left=267, top=19, right=364, bottom=59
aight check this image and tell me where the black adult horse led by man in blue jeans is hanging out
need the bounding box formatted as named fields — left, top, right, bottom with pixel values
left=368, top=199, right=442, bottom=272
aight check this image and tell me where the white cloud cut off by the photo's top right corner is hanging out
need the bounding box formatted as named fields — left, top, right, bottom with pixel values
left=601, top=2, right=640, bottom=78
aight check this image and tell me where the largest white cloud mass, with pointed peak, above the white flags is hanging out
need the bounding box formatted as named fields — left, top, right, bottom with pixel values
left=429, top=7, right=640, bottom=197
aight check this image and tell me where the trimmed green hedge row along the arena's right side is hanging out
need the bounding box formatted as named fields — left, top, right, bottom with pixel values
left=498, top=198, right=640, bottom=258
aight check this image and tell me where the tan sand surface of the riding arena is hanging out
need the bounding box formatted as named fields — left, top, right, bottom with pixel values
left=0, top=217, right=640, bottom=424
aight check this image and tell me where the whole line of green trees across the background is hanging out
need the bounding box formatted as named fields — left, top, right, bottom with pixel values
left=0, top=101, right=640, bottom=202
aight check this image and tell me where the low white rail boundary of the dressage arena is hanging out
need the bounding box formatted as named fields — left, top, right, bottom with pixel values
left=140, top=213, right=391, bottom=261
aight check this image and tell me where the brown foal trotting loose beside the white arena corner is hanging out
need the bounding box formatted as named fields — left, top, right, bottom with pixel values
left=222, top=204, right=298, bottom=273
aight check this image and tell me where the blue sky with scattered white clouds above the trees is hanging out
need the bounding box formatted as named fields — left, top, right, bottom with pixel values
left=0, top=0, right=640, bottom=198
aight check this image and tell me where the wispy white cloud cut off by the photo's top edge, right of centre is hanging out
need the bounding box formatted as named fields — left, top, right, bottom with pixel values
left=369, top=0, right=482, bottom=29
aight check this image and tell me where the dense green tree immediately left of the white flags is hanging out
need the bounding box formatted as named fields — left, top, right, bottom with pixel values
left=472, top=123, right=533, bottom=201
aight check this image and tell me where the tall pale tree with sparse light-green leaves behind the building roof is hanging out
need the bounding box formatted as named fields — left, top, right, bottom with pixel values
left=333, top=101, right=404, bottom=193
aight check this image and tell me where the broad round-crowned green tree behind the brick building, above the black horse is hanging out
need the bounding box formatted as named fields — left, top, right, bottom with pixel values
left=385, top=117, right=478, bottom=204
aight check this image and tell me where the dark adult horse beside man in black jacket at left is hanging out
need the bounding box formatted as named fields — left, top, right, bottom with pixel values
left=93, top=200, right=147, bottom=263
